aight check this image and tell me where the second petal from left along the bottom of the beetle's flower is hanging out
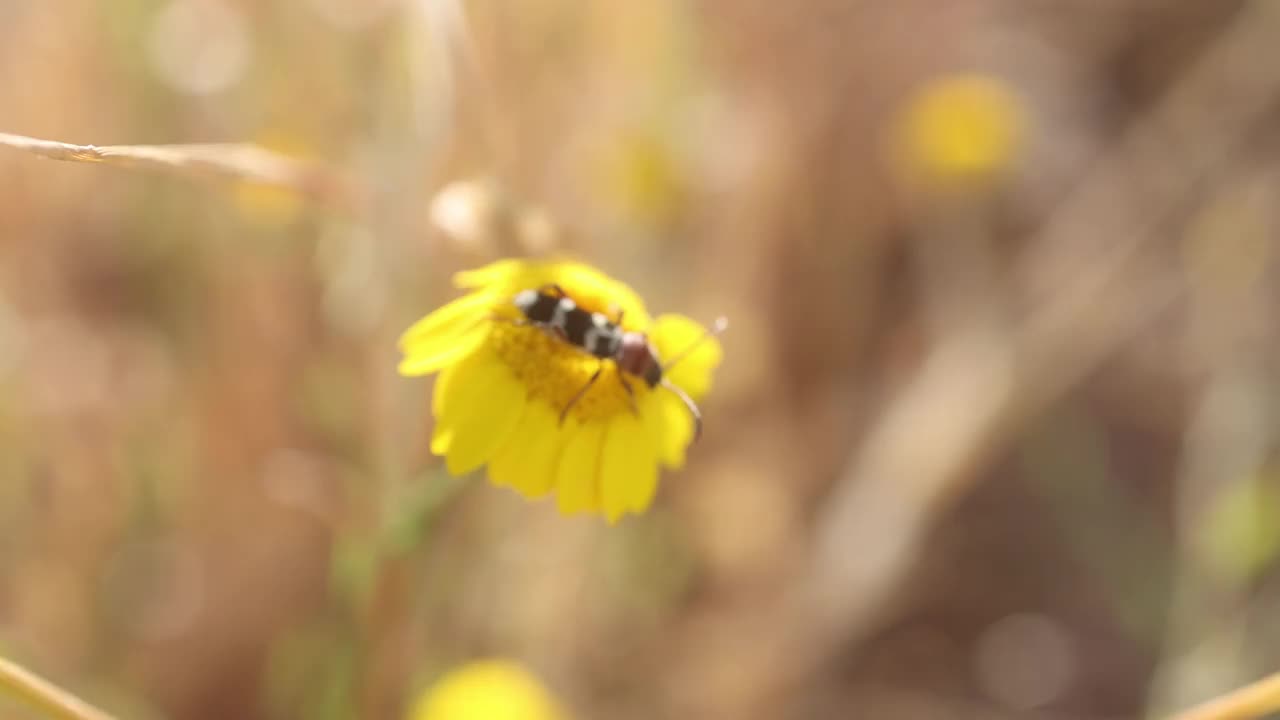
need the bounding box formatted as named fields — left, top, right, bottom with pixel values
left=489, top=400, right=564, bottom=500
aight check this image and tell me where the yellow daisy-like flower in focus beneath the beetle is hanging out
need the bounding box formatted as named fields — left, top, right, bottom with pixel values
left=399, top=260, right=722, bottom=523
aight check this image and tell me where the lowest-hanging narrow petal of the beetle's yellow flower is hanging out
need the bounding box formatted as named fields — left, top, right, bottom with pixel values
left=600, top=414, right=658, bottom=523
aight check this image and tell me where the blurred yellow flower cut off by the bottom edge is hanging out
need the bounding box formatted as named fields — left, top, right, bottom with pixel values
left=407, top=660, right=568, bottom=720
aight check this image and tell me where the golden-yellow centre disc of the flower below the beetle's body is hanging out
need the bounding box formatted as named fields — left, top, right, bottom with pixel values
left=489, top=322, right=649, bottom=423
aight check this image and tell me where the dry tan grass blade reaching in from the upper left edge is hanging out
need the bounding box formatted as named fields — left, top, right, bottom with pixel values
left=0, top=132, right=362, bottom=213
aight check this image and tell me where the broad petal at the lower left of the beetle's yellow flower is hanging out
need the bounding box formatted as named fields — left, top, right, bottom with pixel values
left=431, top=350, right=525, bottom=475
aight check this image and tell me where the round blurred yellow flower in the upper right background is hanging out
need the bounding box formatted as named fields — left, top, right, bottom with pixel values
left=896, top=74, right=1024, bottom=183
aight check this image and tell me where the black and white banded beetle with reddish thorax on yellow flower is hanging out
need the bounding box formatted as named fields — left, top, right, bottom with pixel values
left=512, top=284, right=728, bottom=441
